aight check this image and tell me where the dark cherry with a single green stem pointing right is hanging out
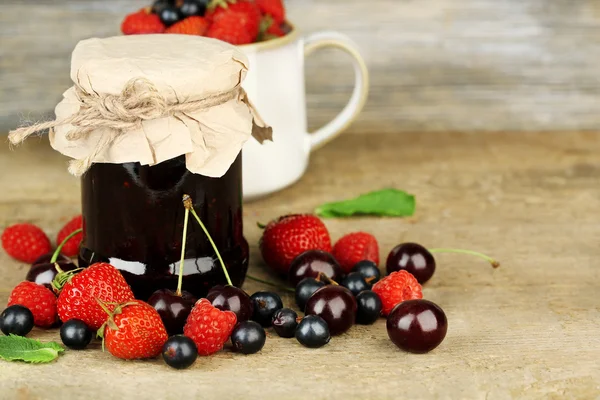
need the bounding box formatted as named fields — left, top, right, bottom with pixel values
left=386, top=243, right=435, bottom=284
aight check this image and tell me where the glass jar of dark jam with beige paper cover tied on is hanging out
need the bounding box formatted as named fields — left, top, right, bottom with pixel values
left=24, top=35, right=271, bottom=300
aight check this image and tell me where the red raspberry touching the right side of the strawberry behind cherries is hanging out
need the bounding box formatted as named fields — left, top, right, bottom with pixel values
left=333, top=232, right=379, bottom=273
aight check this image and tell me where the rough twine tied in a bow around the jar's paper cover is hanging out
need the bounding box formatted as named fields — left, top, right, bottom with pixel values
left=8, top=78, right=272, bottom=176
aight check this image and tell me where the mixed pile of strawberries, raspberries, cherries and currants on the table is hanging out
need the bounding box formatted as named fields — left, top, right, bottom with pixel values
left=0, top=209, right=498, bottom=369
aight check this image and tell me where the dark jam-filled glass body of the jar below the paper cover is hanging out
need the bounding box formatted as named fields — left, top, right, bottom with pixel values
left=79, top=154, right=248, bottom=300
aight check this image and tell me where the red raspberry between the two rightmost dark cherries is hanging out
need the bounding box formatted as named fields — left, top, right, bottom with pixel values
left=372, top=270, right=423, bottom=315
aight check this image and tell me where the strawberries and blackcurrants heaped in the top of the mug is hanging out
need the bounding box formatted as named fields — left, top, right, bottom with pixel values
left=121, top=0, right=289, bottom=45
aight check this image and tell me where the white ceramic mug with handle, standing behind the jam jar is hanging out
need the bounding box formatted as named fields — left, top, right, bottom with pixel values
left=240, top=30, right=369, bottom=200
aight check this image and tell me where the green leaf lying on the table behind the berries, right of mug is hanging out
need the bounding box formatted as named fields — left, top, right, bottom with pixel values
left=315, top=189, right=415, bottom=218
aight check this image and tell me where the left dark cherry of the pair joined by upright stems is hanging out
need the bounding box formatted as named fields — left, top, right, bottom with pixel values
left=148, top=289, right=197, bottom=336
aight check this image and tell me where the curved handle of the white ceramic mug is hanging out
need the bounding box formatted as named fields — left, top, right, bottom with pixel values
left=304, top=32, right=369, bottom=150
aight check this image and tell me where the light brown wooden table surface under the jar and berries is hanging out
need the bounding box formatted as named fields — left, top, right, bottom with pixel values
left=0, top=133, right=600, bottom=399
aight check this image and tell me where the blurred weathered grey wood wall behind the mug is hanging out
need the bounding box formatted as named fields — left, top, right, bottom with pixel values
left=0, top=0, right=600, bottom=133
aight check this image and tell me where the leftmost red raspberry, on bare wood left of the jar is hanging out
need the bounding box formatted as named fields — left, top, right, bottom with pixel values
left=2, top=224, right=52, bottom=264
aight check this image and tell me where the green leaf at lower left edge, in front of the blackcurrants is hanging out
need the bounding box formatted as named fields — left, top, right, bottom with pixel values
left=0, top=335, right=65, bottom=363
